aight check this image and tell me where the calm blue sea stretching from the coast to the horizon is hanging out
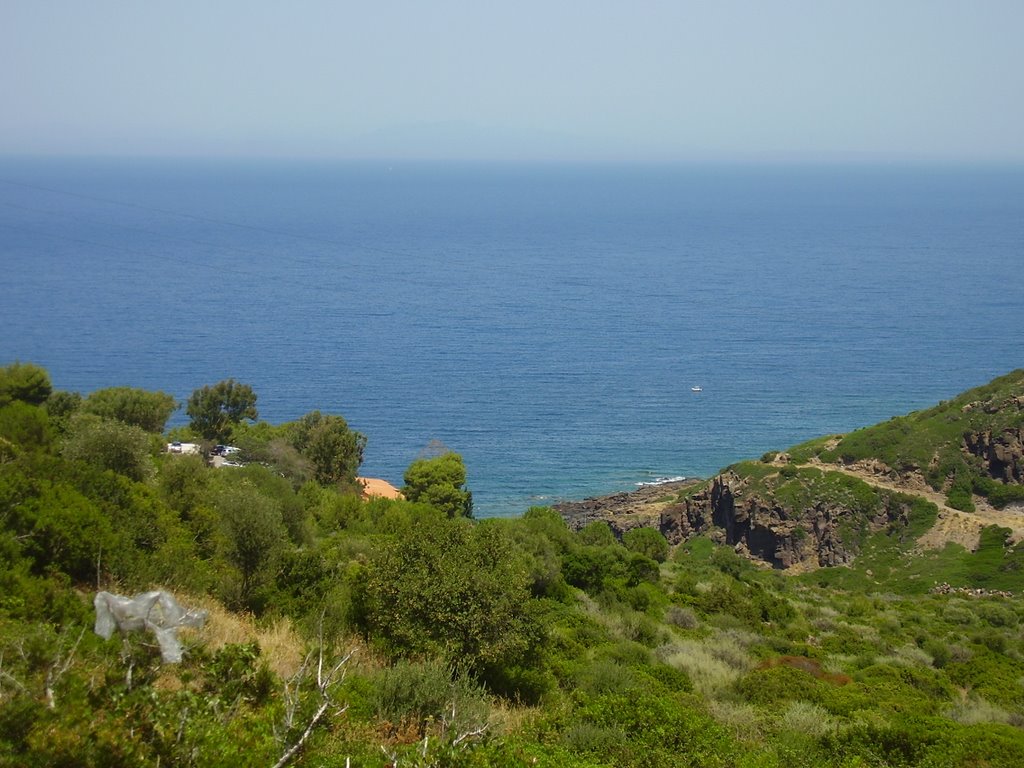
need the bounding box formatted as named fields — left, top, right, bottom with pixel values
left=0, top=159, right=1024, bottom=516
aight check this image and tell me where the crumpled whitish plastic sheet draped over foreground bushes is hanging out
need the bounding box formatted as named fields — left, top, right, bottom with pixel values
left=93, top=590, right=206, bottom=664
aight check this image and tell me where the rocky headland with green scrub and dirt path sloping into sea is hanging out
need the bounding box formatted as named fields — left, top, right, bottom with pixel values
left=555, top=371, right=1024, bottom=568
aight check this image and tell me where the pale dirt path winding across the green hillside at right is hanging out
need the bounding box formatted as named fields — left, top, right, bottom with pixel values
left=786, top=458, right=1024, bottom=552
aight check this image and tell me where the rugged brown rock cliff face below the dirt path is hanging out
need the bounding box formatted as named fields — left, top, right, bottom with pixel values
left=658, top=472, right=908, bottom=568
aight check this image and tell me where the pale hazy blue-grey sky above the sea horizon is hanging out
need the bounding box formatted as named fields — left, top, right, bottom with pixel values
left=0, top=0, right=1024, bottom=162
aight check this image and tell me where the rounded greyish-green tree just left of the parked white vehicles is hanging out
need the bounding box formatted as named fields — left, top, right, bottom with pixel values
left=62, top=414, right=154, bottom=480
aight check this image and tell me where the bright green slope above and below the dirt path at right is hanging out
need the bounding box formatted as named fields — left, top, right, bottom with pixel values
left=667, top=370, right=1024, bottom=594
